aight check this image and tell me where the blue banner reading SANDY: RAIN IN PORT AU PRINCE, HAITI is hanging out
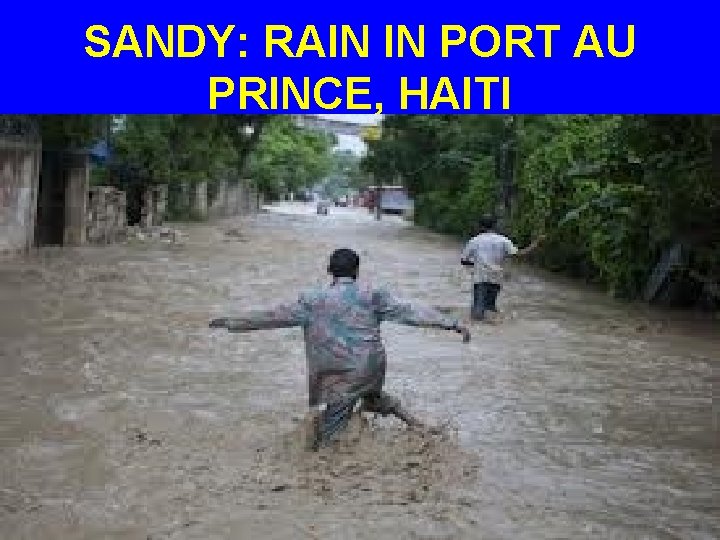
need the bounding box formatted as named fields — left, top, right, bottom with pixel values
left=0, top=0, right=720, bottom=114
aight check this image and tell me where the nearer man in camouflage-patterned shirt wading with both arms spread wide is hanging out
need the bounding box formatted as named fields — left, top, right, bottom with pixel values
left=210, top=249, right=470, bottom=450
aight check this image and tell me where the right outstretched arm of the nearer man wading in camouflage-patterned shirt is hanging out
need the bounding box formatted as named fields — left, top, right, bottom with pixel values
left=375, top=289, right=470, bottom=342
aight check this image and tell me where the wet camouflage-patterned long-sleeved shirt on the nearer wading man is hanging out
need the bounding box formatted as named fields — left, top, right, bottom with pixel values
left=227, top=279, right=458, bottom=406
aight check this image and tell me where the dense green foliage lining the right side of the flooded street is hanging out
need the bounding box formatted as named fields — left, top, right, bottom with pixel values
left=363, top=115, right=720, bottom=304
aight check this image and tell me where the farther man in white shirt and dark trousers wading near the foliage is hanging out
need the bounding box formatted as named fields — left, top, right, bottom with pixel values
left=460, top=217, right=544, bottom=321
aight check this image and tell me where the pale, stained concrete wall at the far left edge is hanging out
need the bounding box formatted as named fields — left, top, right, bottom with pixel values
left=0, top=139, right=42, bottom=253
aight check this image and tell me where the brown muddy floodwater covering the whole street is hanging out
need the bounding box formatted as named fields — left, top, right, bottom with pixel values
left=0, top=204, right=720, bottom=540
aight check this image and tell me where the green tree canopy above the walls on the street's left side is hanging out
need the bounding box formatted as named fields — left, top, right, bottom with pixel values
left=103, top=115, right=334, bottom=219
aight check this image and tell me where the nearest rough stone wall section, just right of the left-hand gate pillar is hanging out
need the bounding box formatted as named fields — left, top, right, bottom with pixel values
left=87, top=186, right=127, bottom=244
